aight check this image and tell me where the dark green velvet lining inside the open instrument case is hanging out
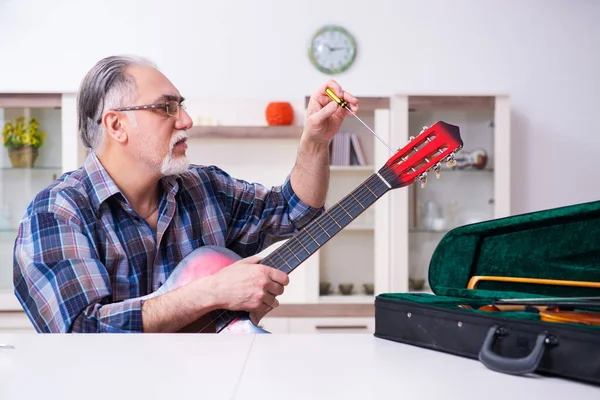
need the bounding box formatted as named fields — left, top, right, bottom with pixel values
left=379, top=201, right=600, bottom=329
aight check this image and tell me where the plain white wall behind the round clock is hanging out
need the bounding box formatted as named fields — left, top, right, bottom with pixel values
left=0, top=0, right=600, bottom=216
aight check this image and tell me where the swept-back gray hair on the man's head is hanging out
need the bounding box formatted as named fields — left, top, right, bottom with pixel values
left=77, top=55, right=156, bottom=152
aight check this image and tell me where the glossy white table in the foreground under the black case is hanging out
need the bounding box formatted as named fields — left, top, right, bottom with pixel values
left=0, top=334, right=600, bottom=400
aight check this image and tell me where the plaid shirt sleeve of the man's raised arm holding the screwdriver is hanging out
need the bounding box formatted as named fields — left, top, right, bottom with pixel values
left=202, top=167, right=324, bottom=256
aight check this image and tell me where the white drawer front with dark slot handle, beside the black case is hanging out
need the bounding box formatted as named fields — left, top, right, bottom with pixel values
left=289, top=317, right=375, bottom=333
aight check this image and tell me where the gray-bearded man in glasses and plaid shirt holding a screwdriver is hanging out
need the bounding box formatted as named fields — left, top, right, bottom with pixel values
left=14, top=56, right=358, bottom=332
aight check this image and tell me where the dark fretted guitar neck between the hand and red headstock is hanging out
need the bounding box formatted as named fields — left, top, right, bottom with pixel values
left=261, top=174, right=390, bottom=274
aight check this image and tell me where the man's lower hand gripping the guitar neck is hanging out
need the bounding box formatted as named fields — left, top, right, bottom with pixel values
left=207, top=256, right=289, bottom=323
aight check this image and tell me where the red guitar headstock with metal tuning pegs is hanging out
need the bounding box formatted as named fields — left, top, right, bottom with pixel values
left=379, top=121, right=463, bottom=188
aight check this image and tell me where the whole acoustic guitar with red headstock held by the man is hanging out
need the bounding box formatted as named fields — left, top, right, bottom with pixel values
left=145, top=121, right=463, bottom=333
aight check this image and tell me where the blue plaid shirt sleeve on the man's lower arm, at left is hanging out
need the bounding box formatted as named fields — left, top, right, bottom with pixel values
left=13, top=212, right=143, bottom=333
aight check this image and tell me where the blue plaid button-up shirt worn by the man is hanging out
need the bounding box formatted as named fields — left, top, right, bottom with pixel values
left=13, top=153, right=322, bottom=332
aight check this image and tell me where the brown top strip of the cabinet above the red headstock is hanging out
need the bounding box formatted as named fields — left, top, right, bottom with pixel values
left=408, top=96, right=495, bottom=111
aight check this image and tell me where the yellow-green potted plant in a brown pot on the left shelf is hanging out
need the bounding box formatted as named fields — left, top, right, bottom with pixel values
left=2, top=117, right=46, bottom=168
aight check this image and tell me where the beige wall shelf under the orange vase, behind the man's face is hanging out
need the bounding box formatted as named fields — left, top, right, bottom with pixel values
left=189, top=125, right=304, bottom=139
